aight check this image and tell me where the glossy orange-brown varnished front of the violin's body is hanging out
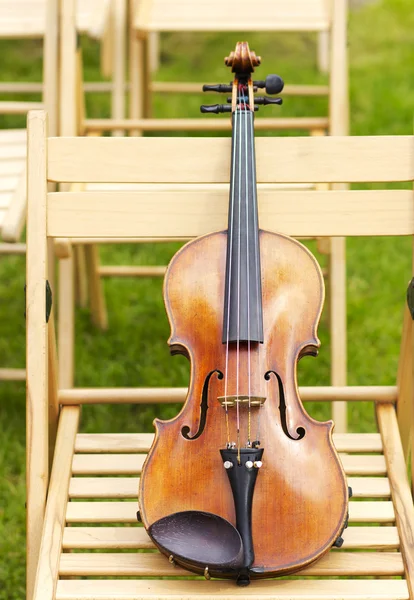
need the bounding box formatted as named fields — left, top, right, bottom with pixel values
left=140, top=231, right=347, bottom=577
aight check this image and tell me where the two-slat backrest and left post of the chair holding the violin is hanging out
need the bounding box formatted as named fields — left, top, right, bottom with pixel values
left=27, top=111, right=414, bottom=412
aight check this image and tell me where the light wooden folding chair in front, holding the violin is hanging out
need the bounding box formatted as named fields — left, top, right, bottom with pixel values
left=27, top=111, right=414, bottom=600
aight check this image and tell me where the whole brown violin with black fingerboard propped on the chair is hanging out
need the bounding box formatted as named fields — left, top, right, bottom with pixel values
left=139, top=42, right=348, bottom=585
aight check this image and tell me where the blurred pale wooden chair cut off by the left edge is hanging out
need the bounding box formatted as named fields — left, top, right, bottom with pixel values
left=0, top=0, right=58, bottom=381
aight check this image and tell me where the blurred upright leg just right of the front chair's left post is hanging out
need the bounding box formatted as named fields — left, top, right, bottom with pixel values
left=58, top=254, right=75, bottom=388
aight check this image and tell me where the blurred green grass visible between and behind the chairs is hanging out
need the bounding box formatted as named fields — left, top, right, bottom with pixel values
left=0, top=0, right=414, bottom=600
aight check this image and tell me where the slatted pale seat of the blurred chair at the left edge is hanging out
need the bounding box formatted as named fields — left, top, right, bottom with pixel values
left=0, top=128, right=26, bottom=242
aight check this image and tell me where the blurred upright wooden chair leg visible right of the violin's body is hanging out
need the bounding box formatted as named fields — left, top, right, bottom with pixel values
left=329, top=238, right=347, bottom=433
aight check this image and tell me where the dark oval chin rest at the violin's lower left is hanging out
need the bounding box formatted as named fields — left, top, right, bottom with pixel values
left=148, top=510, right=243, bottom=576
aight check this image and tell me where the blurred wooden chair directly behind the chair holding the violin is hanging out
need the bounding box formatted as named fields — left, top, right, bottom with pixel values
left=59, top=0, right=349, bottom=431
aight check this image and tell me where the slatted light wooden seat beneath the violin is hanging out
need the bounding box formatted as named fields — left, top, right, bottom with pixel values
left=56, top=433, right=409, bottom=600
